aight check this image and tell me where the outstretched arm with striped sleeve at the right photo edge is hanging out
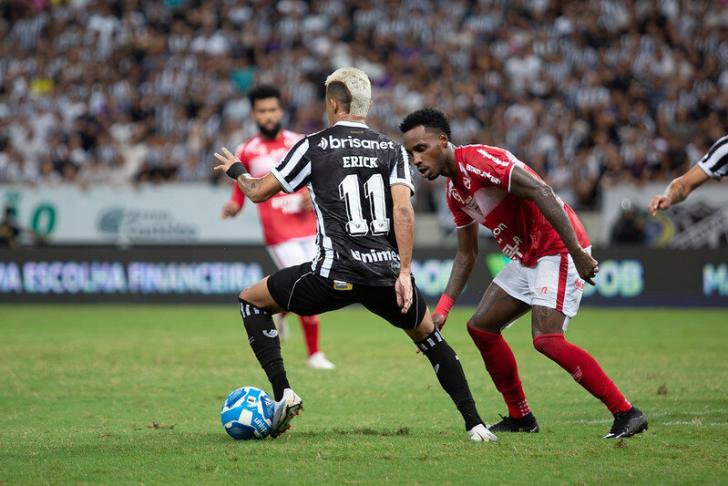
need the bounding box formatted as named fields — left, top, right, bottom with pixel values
left=647, top=135, right=728, bottom=216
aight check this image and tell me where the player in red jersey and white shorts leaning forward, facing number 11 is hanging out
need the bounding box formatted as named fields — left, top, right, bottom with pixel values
left=400, top=108, right=647, bottom=438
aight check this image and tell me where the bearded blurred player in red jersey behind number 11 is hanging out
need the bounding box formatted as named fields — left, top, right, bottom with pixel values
left=222, top=85, right=334, bottom=370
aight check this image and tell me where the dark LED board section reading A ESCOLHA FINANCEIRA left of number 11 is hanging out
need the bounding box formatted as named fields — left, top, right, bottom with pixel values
left=0, top=246, right=275, bottom=302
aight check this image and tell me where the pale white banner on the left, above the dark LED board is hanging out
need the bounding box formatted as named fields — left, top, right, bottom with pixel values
left=0, top=184, right=263, bottom=245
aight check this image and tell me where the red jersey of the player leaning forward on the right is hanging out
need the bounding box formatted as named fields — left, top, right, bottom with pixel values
left=445, top=145, right=590, bottom=267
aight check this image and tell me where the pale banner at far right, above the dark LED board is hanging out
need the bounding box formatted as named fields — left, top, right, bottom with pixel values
left=602, top=182, right=728, bottom=249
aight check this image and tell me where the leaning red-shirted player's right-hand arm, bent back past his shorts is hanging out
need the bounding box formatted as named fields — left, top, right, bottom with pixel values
left=510, top=166, right=599, bottom=285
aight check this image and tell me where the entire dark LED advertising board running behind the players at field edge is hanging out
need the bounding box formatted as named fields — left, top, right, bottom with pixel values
left=0, top=245, right=728, bottom=307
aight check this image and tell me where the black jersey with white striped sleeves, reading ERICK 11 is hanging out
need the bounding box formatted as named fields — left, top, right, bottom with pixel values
left=271, top=121, right=414, bottom=286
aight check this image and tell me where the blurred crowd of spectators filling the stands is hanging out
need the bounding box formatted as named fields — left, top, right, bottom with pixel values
left=0, top=0, right=728, bottom=210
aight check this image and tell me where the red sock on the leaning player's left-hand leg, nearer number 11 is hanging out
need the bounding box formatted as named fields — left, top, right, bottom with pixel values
left=468, top=326, right=531, bottom=418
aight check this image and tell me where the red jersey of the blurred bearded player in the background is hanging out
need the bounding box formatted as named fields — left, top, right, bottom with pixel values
left=230, top=130, right=316, bottom=246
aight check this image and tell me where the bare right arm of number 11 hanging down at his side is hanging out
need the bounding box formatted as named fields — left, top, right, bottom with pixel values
left=391, top=184, right=415, bottom=314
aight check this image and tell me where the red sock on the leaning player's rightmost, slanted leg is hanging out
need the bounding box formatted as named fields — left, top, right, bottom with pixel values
left=533, top=334, right=632, bottom=414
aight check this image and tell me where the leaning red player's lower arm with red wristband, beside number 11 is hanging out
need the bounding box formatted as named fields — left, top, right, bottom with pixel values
left=432, top=222, right=478, bottom=329
